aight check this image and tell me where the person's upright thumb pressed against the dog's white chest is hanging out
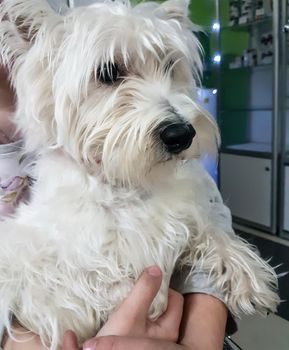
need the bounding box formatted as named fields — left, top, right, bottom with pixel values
left=119, top=266, right=162, bottom=320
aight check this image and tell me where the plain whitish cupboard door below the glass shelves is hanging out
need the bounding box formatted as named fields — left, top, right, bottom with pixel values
left=220, top=152, right=272, bottom=227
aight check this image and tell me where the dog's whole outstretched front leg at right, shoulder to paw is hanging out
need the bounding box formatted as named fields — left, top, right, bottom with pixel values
left=180, top=164, right=280, bottom=316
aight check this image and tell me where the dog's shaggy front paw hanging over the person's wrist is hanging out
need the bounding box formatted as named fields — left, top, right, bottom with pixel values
left=182, top=226, right=280, bottom=317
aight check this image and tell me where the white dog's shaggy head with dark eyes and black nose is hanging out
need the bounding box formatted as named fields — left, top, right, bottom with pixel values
left=0, top=0, right=219, bottom=189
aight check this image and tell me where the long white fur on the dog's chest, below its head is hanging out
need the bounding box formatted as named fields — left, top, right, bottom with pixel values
left=0, top=153, right=202, bottom=342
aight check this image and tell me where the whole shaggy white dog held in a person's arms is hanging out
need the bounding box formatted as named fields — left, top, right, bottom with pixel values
left=0, top=0, right=279, bottom=349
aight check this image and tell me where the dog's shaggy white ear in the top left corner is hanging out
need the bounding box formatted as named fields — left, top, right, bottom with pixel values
left=0, top=0, right=59, bottom=68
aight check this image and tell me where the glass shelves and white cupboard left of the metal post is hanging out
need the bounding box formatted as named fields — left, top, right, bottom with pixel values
left=218, top=0, right=279, bottom=234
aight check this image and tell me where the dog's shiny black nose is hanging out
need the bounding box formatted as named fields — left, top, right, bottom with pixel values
left=160, top=123, right=196, bottom=154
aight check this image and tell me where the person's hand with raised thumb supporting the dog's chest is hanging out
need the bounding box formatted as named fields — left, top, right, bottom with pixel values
left=63, top=267, right=183, bottom=350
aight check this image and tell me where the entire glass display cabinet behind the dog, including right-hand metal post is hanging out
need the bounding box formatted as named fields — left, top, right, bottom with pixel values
left=216, top=0, right=289, bottom=239
